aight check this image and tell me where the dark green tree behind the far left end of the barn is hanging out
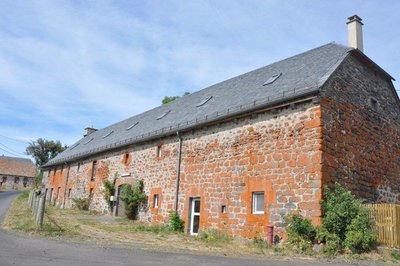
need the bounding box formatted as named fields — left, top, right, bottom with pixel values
left=25, top=138, right=68, bottom=167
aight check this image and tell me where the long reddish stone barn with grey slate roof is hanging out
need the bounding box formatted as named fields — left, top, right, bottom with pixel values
left=43, top=16, right=400, bottom=238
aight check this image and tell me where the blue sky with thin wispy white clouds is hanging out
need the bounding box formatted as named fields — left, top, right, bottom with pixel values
left=0, top=0, right=400, bottom=160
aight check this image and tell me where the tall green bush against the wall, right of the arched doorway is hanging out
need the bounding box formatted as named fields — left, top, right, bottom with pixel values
left=121, top=180, right=147, bottom=220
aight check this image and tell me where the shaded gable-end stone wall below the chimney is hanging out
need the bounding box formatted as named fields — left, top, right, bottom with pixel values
left=321, top=56, right=400, bottom=203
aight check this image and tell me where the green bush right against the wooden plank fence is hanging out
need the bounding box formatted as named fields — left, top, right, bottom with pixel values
left=344, top=209, right=376, bottom=253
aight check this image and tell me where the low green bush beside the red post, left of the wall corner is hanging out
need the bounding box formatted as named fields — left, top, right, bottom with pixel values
left=285, top=214, right=316, bottom=252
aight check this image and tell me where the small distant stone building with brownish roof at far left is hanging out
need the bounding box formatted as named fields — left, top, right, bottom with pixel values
left=0, top=155, right=37, bottom=189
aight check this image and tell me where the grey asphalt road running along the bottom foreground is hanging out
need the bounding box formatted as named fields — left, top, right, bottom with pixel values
left=0, top=191, right=376, bottom=266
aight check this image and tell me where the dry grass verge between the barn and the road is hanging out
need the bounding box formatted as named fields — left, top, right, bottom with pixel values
left=3, top=192, right=400, bottom=263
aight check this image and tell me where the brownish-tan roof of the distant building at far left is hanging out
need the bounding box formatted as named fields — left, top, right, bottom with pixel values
left=0, top=155, right=36, bottom=177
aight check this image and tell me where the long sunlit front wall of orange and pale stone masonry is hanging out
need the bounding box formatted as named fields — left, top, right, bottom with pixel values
left=44, top=101, right=322, bottom=238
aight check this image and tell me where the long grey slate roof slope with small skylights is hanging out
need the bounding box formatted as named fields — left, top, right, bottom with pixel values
left=44, top=43, right=354, bottom=168
